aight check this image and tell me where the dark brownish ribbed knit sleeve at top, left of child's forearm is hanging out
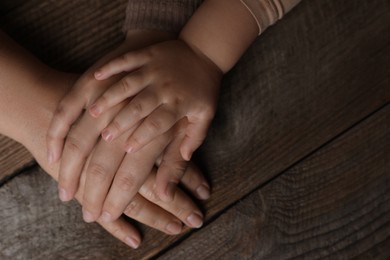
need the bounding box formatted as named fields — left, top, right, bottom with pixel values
left=123, top=0, right=202, bottom=34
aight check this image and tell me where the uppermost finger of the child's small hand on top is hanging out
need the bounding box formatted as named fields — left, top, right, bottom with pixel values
left=94, top=50, right=149, bottom=80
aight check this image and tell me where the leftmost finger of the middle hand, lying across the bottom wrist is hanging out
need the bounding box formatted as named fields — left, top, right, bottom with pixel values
left=46, top=90, right=85, bottom=163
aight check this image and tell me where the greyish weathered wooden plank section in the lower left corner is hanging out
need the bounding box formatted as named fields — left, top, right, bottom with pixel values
left=0, top=168, right=136, bottom=260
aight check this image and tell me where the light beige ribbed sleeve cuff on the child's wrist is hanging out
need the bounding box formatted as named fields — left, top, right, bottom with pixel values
left=241, top=0, right=301, bottom=34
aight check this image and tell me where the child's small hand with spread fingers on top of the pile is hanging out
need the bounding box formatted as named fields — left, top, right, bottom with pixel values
left=89, top=40, right=222, bottom=160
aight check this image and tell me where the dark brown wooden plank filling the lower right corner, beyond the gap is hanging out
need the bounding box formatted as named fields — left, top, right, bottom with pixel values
left=161, top=105, right=390, bottom=259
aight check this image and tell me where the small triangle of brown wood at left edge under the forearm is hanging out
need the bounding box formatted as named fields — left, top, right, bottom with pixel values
left=0, top=135, right=33, bottom=183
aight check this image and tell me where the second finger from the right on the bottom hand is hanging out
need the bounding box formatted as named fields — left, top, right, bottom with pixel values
left=139, top=168, right=203, bottom=228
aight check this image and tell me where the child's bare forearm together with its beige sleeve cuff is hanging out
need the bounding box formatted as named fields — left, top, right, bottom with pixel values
left=179, top=0, right=300, bottom=73
